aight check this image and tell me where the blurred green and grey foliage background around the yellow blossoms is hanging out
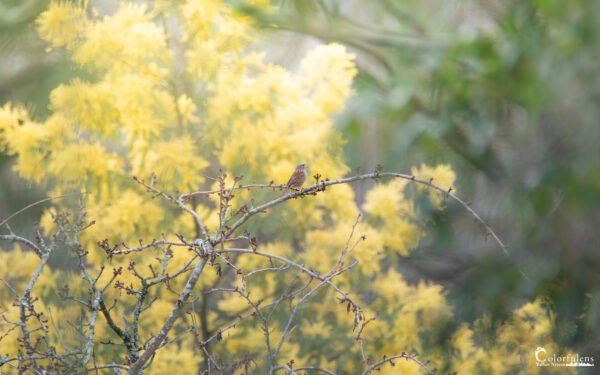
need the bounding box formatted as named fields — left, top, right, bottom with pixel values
left=0, top=0, right=600, bottom=368
